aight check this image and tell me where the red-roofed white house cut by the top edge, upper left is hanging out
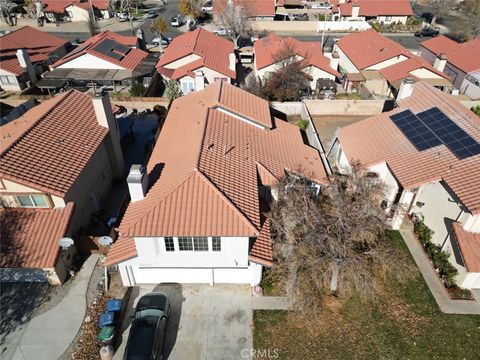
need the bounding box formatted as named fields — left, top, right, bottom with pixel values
left=40, top=0, right=112, bottom=22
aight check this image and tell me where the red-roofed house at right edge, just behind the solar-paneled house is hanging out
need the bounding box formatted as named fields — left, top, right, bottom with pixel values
left=420, top=35, right=480, bottom=100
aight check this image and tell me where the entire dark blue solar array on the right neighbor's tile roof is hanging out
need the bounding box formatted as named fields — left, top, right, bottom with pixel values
left=390, top=107, right=480, bottom=159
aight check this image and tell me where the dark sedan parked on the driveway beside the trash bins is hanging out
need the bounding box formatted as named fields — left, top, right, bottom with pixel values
left=123, top=293, right=170, bottom=360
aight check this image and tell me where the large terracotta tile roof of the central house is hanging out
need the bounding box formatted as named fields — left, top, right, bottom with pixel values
left=106, top=81, right=328, bottom=264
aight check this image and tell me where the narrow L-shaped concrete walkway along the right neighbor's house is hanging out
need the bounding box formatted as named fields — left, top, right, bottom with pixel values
left=400, top=223, right=480, bottom=315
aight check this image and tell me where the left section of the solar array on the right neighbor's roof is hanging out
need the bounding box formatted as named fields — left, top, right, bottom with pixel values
left=390, top=110, right=442, bottom=151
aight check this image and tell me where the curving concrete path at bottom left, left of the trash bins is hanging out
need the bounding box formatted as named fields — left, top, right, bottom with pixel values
left=12, top=255, right=98, bottom=360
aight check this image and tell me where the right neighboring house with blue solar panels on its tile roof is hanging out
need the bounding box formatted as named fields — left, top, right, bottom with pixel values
left=329, top=81, right=480, bottom=288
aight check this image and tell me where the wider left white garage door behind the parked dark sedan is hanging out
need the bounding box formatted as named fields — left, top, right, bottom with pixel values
left=132, top=266, right=212, bottom=284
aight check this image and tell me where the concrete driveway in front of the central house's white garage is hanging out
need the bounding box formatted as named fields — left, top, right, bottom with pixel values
left=114, top=284, right=253, bottom=360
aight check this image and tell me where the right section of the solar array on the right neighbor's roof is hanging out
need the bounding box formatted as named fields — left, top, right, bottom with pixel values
left=417, top=107, right=480, bottom=159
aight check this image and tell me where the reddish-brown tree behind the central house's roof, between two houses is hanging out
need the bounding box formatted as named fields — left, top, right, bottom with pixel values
left=265, top=42, right=311, bottom=101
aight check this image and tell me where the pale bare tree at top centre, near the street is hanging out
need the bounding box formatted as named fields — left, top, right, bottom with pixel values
left=218, top=2, right=250, bottom=48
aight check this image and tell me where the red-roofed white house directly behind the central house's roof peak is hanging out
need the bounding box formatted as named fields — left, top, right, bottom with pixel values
left=157, top=28, right=237, bottom=95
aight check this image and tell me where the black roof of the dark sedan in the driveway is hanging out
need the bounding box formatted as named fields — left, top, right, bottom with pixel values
left=127, top=317, right=157, bottom=360
